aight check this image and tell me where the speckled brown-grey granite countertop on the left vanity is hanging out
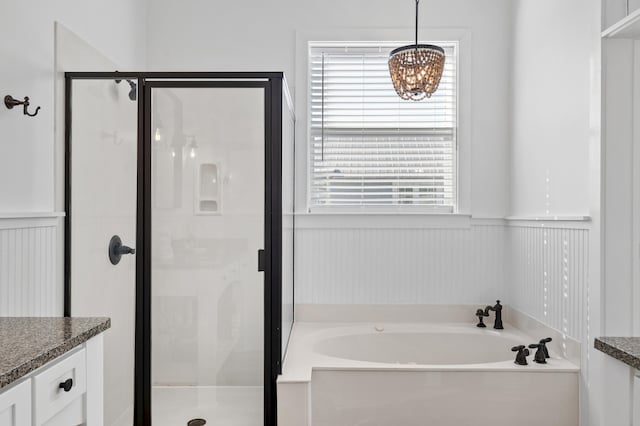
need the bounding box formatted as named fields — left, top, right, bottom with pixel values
left=0, top=317, right=111, bottom=389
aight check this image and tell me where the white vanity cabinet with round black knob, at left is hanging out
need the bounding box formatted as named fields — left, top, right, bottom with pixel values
left=0, top=334, right=103, bottom=426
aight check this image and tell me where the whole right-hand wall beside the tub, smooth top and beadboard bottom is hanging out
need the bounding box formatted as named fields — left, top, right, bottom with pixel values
left=508, top=0, right=604, bottom=425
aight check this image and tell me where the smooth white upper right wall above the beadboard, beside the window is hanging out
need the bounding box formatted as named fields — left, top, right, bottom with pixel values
left=510, top=0, right=598, bottom=216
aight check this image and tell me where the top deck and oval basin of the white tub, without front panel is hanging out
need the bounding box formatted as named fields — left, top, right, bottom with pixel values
left=279, top=323, right=580, bottom=382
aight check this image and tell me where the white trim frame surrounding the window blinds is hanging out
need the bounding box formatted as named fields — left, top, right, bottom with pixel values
left=304, top=37, right=466, bottom=215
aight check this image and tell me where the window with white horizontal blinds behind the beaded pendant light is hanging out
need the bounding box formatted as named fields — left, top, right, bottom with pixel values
left=309, top=42, right=457, bottom=212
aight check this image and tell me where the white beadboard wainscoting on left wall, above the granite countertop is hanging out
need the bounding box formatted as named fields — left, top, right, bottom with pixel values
left=0, top=218, right=63, bottom=316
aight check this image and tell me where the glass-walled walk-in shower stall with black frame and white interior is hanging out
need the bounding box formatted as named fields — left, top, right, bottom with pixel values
left=65, top=72, right=294, bottom=426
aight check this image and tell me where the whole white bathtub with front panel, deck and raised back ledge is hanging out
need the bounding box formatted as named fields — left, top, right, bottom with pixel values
left=278, top=306, right=580, bottom=426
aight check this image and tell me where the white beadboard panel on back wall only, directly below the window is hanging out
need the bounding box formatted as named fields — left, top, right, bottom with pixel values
left=295, top=222, right=507, bottom=304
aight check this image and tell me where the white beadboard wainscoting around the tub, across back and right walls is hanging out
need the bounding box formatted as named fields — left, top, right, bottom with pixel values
left=295, top=218, right=589, bottom=341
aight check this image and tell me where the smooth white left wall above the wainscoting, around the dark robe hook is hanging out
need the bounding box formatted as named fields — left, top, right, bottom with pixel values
left=0, top=0, right=146, bottom=212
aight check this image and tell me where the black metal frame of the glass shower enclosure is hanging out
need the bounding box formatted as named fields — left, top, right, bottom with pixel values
left=64, top=72, right=284, bottom=426
